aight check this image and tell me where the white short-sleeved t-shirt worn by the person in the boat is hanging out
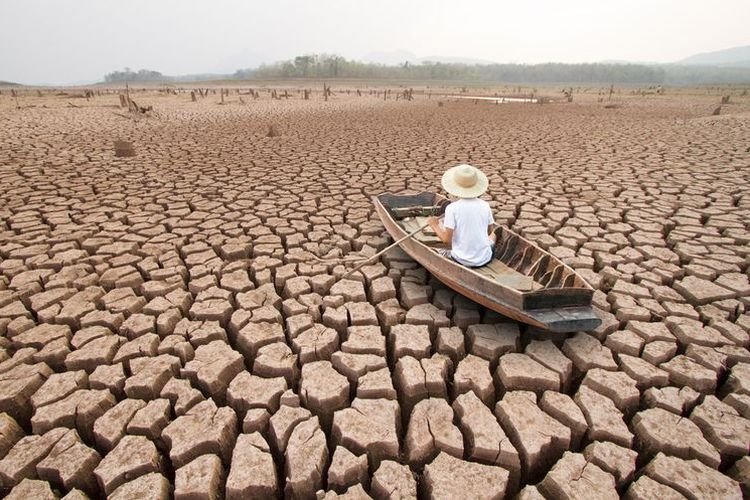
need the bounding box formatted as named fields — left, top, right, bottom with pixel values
left=443, top=198, right=495, bottom=267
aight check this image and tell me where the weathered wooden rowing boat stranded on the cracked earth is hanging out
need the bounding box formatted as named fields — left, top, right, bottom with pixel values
left=373, top=192, right=601, bottom=332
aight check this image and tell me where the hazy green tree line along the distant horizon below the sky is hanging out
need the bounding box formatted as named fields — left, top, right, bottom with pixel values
left=105, top=54, right=750, bottom=85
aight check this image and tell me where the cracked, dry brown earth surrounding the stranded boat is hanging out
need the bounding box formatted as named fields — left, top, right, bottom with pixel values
left=0, top=90, right=750, bottom=499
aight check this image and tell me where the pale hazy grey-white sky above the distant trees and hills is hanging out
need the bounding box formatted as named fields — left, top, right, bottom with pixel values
left=0, top=0, right=750, bottom=84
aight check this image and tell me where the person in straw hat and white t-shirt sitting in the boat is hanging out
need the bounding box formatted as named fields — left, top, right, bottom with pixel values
left=427, top=165, right=495, bottom=267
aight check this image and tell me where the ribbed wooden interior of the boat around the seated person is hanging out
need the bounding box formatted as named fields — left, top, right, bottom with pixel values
left=388, top=199, right=587, bottom=292
